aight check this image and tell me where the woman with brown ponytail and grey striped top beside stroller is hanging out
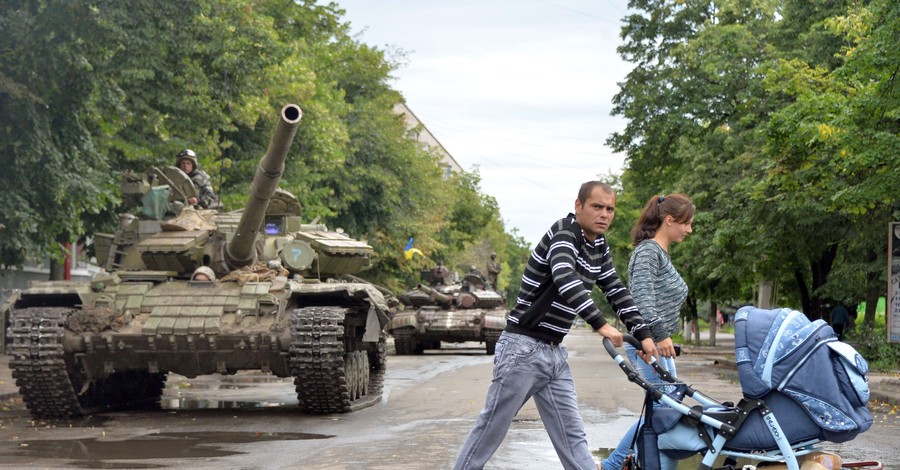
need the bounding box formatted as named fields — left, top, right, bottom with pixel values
left=601, top=194, right=696, bottom=470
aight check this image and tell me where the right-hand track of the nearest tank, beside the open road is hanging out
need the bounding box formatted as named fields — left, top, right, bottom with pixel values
left=290, top=307, right=387, bottom=414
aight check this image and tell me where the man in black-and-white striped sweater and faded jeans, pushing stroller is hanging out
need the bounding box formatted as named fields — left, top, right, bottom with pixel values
left=454, top=181, right=659, bottom=470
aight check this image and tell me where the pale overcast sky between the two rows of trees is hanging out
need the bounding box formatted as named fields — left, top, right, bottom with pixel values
left=336, top=0, right=631, bottom=246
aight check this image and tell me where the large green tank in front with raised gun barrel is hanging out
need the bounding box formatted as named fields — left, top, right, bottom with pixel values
left=0, top=105, right=394, bottom=418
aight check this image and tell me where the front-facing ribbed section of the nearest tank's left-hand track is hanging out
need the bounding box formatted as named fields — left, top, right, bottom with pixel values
left=7, top=307, right=88, bottom=419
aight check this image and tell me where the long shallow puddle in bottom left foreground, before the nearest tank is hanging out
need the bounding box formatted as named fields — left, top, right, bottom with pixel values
left=0, top=432, right=334, bottom=468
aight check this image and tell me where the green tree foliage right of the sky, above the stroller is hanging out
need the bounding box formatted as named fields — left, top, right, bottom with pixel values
left=609, top=0, right=900, bottom=324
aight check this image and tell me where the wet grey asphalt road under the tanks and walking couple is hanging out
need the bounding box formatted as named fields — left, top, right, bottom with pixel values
left=0, top=330, right=900, bottom=470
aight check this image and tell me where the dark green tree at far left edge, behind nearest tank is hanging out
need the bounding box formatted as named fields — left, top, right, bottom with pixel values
left=0, top=1, right=115, bottom=267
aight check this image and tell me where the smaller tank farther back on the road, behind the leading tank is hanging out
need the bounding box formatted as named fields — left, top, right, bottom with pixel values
left=388, top=266, right=506, bottom=355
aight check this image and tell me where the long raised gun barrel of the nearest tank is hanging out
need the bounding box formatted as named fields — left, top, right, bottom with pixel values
left=225, top=104, right=303, bottom=269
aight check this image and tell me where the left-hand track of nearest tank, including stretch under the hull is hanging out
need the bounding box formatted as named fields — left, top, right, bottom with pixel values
left=7, top=307, right=166, bottom=419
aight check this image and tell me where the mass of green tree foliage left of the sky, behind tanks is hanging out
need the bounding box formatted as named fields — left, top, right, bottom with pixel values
left=0, top=0, right=523, bottom=294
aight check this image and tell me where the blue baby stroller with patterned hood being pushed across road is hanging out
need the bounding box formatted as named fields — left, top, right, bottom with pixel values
left=604, top=307, right=881, bottom=470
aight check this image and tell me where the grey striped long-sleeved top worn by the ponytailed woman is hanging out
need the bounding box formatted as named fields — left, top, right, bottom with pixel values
left=628, top=239, right=688, bottom=342
